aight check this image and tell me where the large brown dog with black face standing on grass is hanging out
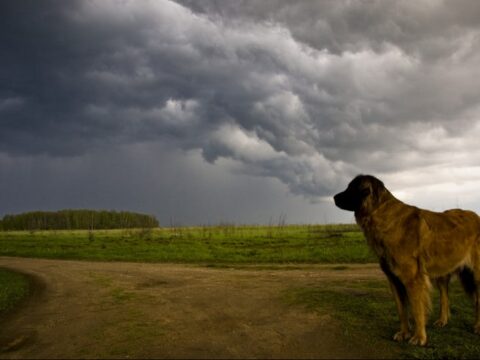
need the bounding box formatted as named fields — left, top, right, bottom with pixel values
left=334, top=175, right=480, bottom=345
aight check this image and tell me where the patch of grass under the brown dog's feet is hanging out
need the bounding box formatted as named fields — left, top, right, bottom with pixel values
left=284, top=279, right=480, bottom=359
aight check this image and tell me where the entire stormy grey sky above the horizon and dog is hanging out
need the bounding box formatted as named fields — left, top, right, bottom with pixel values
left=0, top=0, right=480, bottom=226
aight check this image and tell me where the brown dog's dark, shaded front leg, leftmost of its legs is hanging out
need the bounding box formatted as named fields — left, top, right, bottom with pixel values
left=380, top=259, right=412, bottom=341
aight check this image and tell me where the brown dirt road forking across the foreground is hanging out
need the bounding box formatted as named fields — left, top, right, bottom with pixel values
left=0, top=257, right=381, bottom=358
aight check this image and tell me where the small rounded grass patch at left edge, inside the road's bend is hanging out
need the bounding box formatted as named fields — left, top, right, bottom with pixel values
left=0, top=268, right=30, bottom=316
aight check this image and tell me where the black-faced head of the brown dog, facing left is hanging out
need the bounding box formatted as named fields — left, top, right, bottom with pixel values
left=333, top=175, right=386, bottom=212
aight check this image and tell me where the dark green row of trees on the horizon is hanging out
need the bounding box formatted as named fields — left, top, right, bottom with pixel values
left=0, top=210, right=159, bottom=231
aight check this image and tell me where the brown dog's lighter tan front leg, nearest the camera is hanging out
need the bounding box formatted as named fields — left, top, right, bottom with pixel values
left=405, top=275, right=430, bottom=346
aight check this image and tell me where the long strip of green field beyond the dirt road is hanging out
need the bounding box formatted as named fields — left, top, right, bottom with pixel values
left=0, top=225, right=376, bottom=265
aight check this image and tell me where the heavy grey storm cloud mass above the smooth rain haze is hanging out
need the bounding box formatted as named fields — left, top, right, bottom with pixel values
left=0, top=1, right=480, bottom=197
